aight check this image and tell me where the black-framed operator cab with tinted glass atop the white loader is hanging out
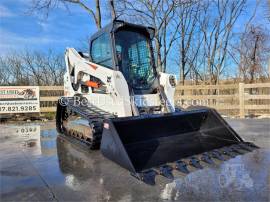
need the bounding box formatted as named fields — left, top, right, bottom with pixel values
left=90, top=21, right=158, bottom=94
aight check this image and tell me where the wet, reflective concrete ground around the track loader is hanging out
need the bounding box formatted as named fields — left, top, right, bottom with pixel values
left=0, top=119, right=270, bottom=201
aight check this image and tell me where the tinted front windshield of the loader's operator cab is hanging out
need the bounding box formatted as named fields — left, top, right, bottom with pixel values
left=115, top=31, right=155, bottom=89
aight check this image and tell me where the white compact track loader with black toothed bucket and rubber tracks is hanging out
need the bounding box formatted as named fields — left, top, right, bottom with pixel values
left=56, top=21, right=257, bottom=184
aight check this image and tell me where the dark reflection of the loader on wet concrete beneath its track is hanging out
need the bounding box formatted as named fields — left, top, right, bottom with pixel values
left=57, top=136, right=158, bottom=201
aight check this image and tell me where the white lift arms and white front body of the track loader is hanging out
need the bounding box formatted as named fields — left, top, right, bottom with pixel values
left=64, top=48, right=176, bottom=117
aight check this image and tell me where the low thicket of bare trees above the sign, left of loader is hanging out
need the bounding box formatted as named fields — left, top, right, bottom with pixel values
left=0, top=51, right=65, bottom=86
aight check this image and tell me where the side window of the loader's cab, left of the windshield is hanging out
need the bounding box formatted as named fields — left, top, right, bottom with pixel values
left=91, top=33, right=112, bottom=68
